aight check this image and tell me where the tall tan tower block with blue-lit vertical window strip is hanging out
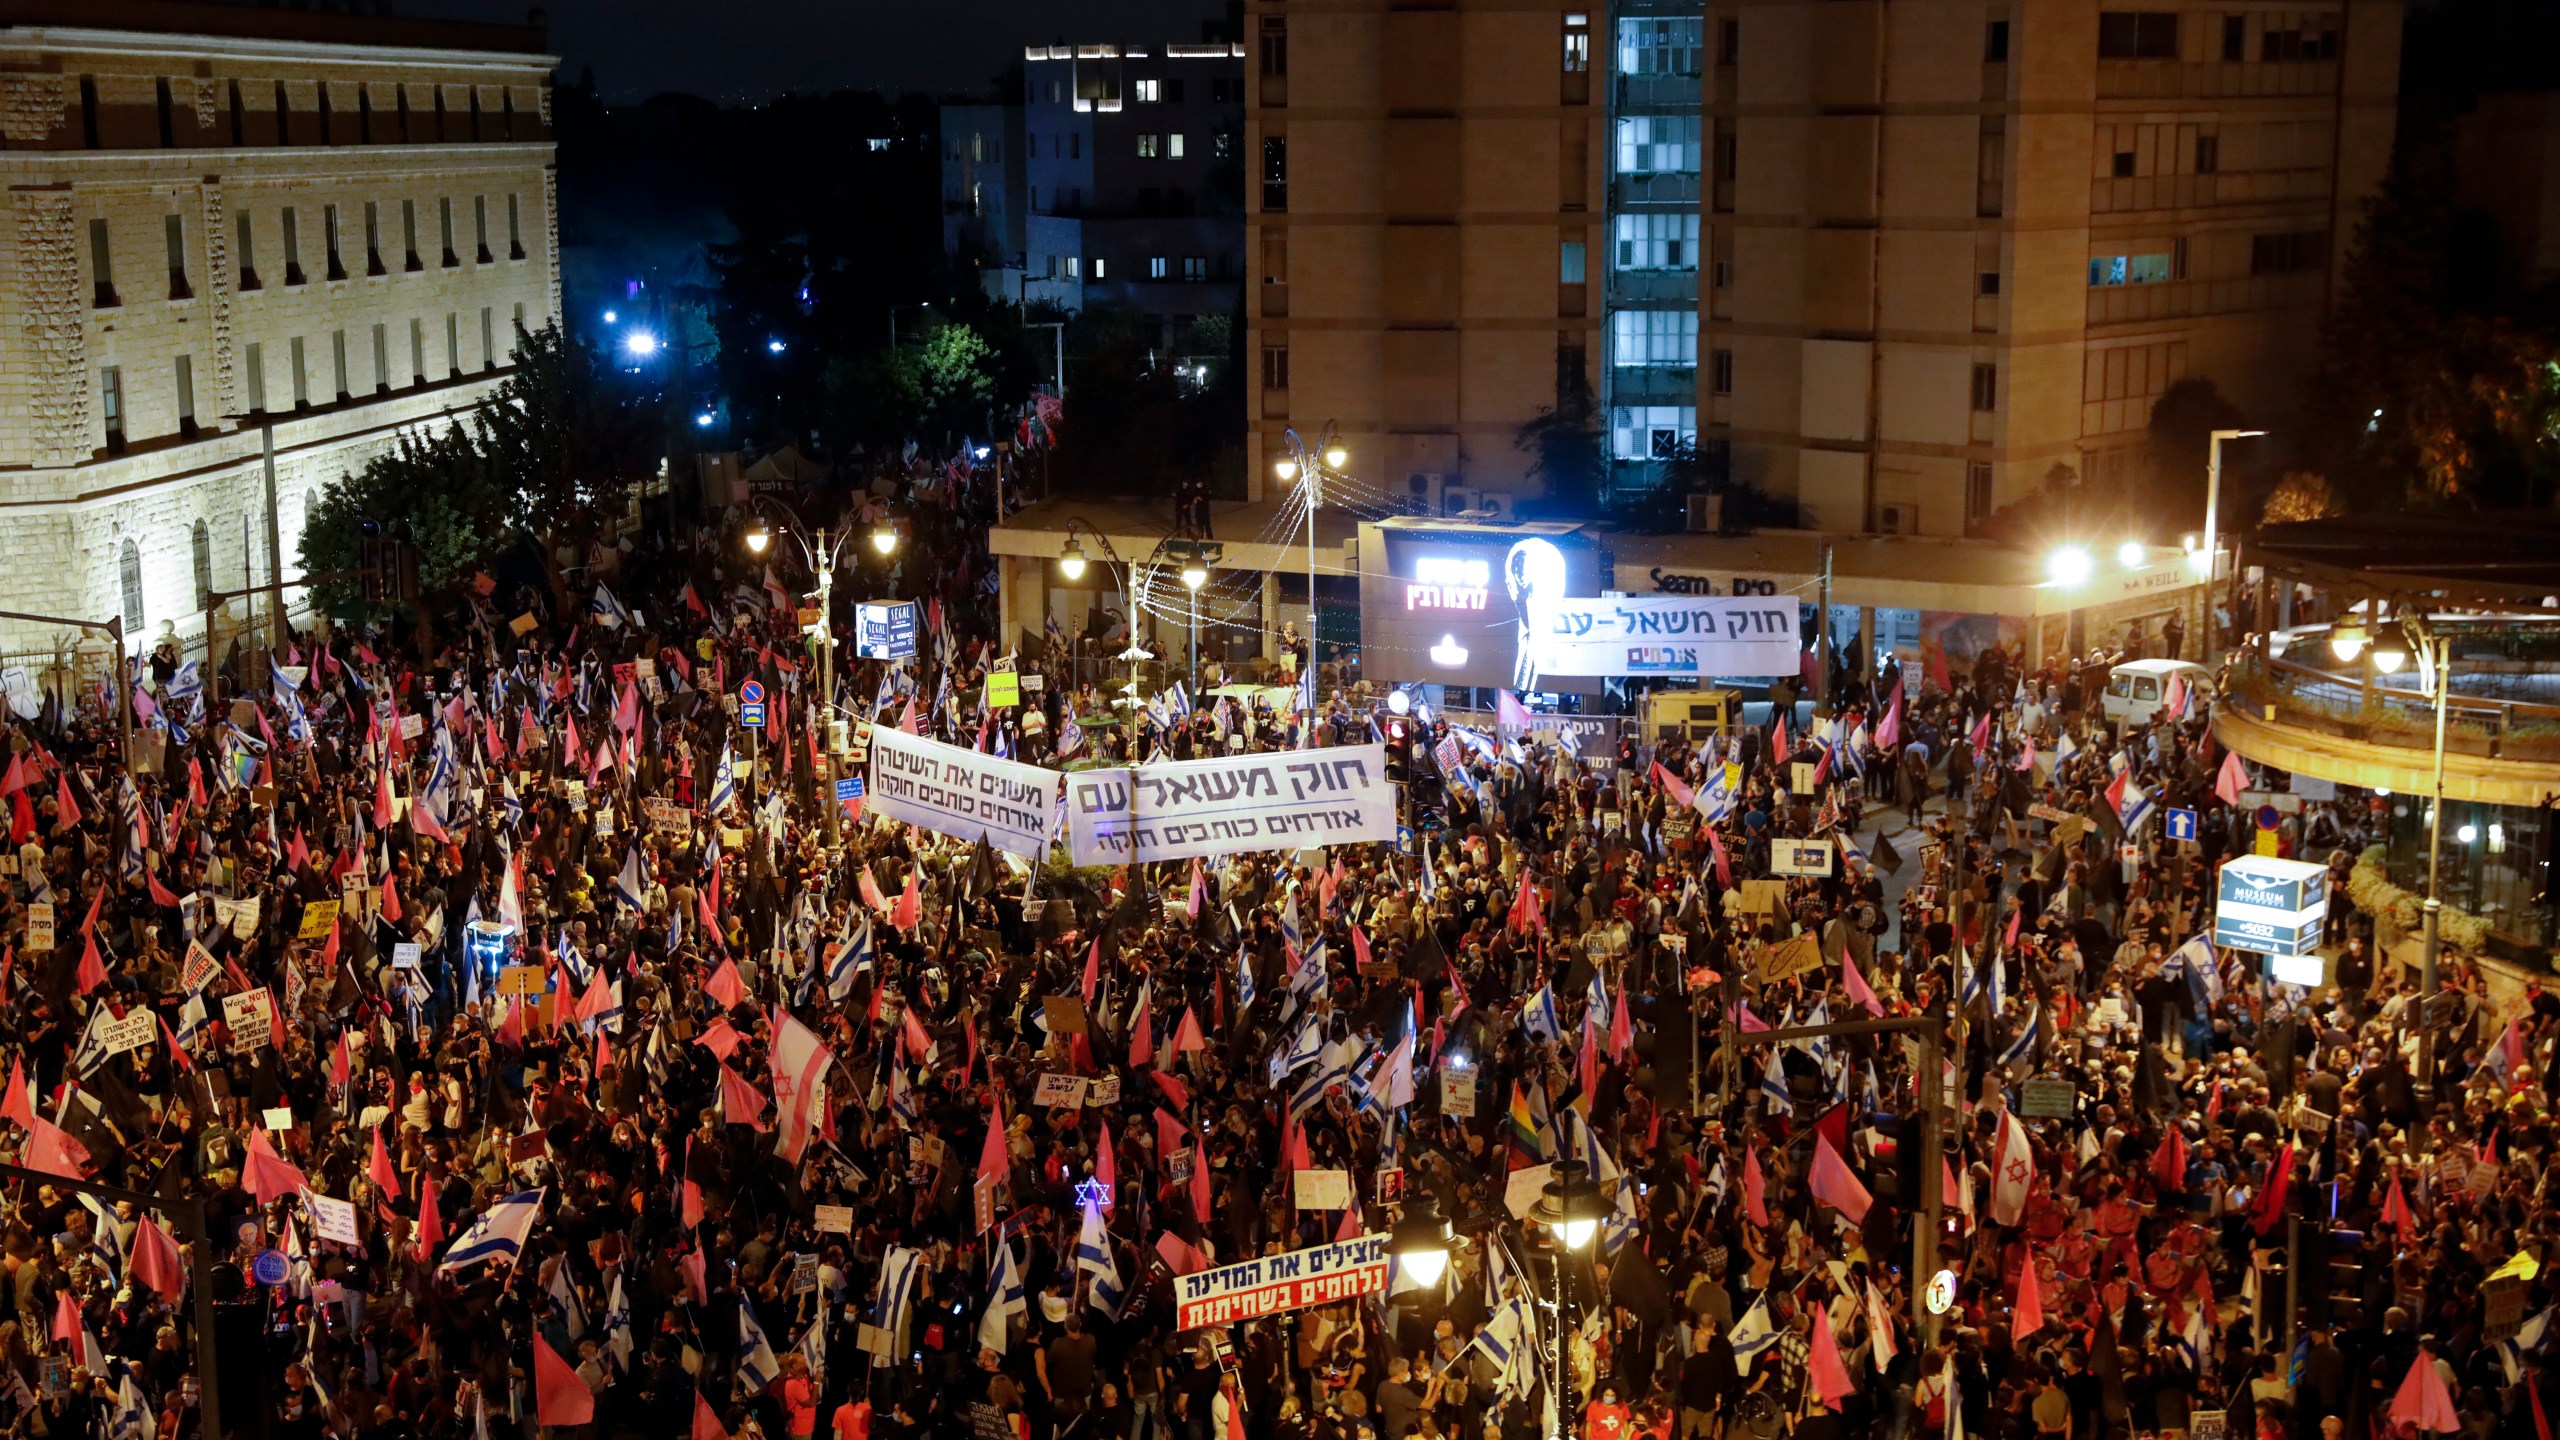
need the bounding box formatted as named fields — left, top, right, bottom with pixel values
left=1244, top=0, right=2401, bottom=536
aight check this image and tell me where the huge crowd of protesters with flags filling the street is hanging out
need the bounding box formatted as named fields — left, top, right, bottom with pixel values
left=0, top=456, right=2555, bottom=1440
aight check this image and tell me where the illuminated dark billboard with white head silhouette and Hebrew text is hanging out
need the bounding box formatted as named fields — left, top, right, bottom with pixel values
left=1359, top=518, right=1600, bottom=694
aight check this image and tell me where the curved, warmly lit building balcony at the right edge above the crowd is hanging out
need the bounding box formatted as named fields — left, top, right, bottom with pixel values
left=2214, top=615, right=2560, bottom=805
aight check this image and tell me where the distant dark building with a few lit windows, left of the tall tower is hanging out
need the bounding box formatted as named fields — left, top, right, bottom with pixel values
left=962, top=41, right=1244, bottom=356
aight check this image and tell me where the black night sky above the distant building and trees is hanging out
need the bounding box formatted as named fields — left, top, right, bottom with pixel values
left=422, top=0, right=1226, bottom=102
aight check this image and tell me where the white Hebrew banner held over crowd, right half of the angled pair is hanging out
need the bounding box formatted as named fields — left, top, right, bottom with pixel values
left=1068, top=746, right=1395, bottom=866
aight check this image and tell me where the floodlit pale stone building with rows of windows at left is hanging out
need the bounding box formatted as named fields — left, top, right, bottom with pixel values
left=0, top=0, right=561, bottom=651
